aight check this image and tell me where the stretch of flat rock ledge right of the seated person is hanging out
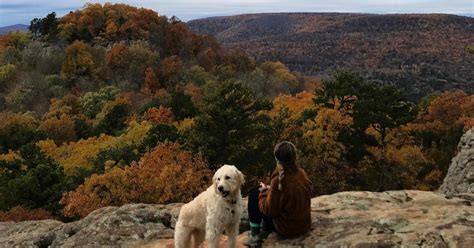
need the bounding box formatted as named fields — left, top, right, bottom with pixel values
left=265, top=190, right=474, bottom=247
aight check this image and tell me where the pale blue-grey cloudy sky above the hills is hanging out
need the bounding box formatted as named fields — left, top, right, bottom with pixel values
left=0, top=0, right=474, bottom=26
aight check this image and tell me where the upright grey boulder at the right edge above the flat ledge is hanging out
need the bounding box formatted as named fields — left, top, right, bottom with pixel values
left=439, top=128, right=474, bottom=195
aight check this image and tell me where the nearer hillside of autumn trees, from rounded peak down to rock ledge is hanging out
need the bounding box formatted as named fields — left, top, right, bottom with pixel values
left=0, top=4, right=474, bottom=221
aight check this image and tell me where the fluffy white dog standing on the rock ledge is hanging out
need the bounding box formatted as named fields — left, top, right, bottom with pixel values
left=174, top=165, right=244, bottom=248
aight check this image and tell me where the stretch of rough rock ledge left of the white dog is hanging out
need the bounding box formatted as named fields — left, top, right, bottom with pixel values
left=0, top=204, right=182, bottom=247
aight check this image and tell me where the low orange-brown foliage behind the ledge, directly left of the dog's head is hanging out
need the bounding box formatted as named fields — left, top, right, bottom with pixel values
left=61, top=143, right=211, bottom=217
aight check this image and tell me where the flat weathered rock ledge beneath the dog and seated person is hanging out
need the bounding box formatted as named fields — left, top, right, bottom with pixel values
left=0, top=190, right=474, bottom=247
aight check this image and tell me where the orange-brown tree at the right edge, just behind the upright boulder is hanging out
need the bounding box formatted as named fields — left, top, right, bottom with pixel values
left=405, top=90, right=474, bottom=189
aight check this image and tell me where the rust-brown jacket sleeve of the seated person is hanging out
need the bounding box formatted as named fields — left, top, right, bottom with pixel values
left=258, top=174, right=282, bottom=218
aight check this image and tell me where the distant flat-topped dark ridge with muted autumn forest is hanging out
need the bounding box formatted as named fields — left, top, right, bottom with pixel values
left=188, top=13, right=474, bottom=98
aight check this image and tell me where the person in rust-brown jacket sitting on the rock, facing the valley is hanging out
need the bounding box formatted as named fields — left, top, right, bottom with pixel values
left=244, top=141, right=311, bottom=247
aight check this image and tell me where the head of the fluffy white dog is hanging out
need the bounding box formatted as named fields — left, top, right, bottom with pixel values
left=212, top=164, right=245, bottom=198
